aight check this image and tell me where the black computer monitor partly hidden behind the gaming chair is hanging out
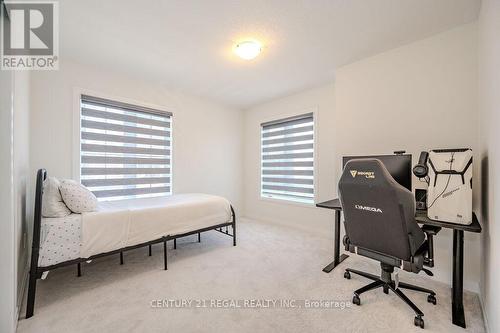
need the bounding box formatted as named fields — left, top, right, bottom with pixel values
left=342, top=154, right=412, bottom=191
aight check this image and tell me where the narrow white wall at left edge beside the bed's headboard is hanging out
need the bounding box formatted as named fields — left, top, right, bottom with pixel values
left=0, top=71, right=30, bottom=332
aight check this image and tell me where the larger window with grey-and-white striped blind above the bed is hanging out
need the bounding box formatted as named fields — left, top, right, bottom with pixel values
left=80, top=95, right=172, bottom=200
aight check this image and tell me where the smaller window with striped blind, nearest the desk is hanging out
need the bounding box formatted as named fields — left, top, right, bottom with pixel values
left=261, top=113, right=314, bottom=204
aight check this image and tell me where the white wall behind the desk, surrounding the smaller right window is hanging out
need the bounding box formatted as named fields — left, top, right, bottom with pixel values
left=244, top=24, right=480, bottom=291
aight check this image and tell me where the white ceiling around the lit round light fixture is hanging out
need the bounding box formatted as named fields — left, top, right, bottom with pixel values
left=60, top=0, right=480, bottom=108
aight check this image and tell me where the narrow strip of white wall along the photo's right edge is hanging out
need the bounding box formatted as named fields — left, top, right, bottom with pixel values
left=478, top=0, right=500, bottom=332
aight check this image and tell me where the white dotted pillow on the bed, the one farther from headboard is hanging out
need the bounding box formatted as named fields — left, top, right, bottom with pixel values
left=59, top=179, right=97, bottom=214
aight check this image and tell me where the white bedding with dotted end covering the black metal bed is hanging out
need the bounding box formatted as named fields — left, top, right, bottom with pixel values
left=39, top=194, right=232, bottom=267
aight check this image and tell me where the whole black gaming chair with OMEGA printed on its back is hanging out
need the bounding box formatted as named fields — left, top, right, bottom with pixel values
left=339, top=158, right=436, bottom=328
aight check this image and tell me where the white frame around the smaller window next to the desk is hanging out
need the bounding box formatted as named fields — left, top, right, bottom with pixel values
left=258, top=106, right=319, bottom=208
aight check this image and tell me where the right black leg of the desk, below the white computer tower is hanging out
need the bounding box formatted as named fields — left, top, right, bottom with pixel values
left=451, top=229, right=465, bottom=328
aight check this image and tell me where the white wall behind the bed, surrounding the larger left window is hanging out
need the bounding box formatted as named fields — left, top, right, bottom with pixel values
left=30, top=62, right=242, bottom=213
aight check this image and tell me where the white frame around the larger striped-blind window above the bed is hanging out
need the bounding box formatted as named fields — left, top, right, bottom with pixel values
left=72, top=88, right=174, bottom=197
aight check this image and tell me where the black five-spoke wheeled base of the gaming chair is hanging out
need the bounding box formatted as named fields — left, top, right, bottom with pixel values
left=344, top=263, right=436, bottom=328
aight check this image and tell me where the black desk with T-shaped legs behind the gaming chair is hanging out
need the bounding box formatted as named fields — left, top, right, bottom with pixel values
left=316, top=199, right=481, bottom=328
